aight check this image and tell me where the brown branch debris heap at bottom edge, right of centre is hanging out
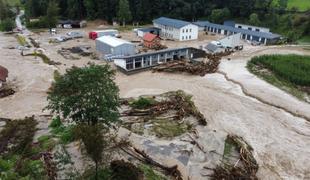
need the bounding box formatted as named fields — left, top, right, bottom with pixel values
left=206, top=135, right=258, bottom=180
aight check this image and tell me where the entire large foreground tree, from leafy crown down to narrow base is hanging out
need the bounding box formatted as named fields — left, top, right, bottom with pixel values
left=47, top=64, right=119, bottom=179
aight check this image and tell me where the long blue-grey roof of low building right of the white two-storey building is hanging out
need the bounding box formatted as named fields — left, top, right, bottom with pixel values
left=193, top=21, right=281, bottom=39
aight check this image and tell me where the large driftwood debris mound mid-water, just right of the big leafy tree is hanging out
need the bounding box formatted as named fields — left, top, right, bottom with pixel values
left=121, top=91, right=207, bottom=139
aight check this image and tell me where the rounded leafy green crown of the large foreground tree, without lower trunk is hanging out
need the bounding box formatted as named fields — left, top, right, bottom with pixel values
left=47, top=64, right=119, bottom=126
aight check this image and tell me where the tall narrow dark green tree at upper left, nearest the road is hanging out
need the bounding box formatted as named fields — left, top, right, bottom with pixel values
left=46, top=0, right=58, bottom=29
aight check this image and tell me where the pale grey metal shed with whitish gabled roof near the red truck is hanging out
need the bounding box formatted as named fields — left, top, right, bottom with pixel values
left=96, top=36, right=136, bottom=56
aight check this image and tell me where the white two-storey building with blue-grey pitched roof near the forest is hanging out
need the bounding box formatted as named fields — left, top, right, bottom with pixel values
left=153, top=17, right=198, bottom=41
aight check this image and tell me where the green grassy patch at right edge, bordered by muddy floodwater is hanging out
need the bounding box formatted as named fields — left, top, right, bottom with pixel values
left=247, top=54, right=310, bottom=102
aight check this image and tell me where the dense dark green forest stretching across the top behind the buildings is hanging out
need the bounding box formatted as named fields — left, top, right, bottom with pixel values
left=0, top=0, right=310, bottom=40
